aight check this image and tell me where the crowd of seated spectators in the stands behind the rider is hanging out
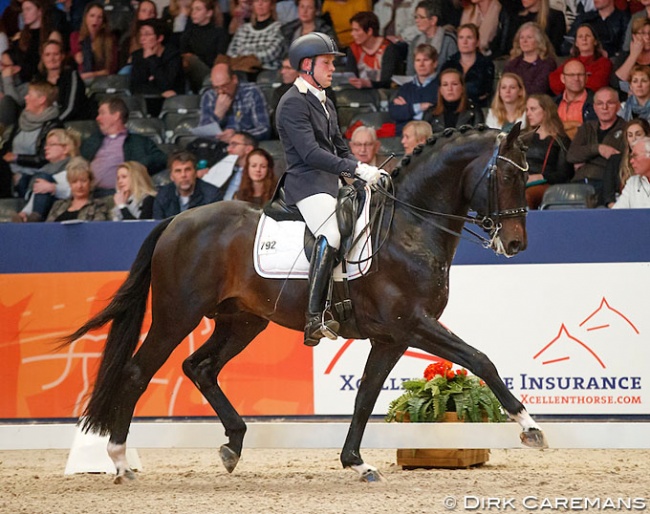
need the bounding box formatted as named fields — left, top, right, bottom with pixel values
left=0, top=0, right=650, bottom=222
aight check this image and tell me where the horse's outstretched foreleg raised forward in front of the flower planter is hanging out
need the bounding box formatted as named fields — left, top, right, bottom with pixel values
left=410, top=320, right=548, bottom=448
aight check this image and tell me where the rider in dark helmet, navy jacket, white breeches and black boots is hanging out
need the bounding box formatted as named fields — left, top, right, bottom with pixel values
left=276, top=32, right=383, bottom=346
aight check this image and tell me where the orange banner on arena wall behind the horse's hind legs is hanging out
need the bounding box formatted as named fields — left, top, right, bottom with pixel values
left=0, top=272, right=314, bottom=419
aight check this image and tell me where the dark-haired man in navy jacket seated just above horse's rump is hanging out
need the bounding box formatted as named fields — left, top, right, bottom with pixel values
left=153, top=152, right=223, bottom=219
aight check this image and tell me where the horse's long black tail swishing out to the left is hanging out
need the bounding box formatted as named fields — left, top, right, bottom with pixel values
left=61, top=218, right=172, bottom=435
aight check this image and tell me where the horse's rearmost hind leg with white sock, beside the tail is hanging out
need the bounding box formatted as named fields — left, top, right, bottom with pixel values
left=108, top=315, right=200, bottom=484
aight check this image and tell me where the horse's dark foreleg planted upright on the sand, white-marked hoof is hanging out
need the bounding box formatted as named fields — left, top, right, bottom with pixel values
left=341, top=340, right=407, bottom=482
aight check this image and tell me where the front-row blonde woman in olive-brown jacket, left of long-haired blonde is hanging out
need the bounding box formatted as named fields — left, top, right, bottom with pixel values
left=47, top=157, right=110, bottom=221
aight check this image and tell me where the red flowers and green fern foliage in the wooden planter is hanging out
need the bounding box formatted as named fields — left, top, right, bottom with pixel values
left=386, top=360, right=506, bottom=422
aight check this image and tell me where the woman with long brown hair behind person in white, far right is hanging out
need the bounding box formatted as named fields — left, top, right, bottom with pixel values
left=603, top=118, right=650, bottom=208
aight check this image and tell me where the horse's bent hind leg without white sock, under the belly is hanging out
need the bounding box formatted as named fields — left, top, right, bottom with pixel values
left=183, top=312, right=269, bottom=473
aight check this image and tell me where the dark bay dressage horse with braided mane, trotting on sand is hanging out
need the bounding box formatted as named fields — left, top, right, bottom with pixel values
left=65, top=122, right=546, bottom=482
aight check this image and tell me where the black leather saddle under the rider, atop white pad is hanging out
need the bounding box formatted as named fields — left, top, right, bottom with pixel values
left=264, top=176, right=366, bottom=264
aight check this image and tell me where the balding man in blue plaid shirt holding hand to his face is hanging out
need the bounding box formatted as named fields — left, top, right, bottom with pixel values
left=199, top=62, right=271, bottom=143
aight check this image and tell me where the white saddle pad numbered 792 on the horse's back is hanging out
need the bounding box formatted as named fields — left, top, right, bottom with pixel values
left=253, top=187, right=372, bottom=282
